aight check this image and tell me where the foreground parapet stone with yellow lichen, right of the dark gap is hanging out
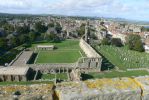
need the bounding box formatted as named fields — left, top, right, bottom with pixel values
left=55, top=76, right=149, bottom=100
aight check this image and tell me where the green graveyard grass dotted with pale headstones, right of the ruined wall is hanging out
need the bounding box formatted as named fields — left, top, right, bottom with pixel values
left=96, top=45, right=149, bottom=70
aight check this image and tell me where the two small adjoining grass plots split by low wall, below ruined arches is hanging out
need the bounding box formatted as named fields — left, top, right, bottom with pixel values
left=41, top=73, right=68, bottom=80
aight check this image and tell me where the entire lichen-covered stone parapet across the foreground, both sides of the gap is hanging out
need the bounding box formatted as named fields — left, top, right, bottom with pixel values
left=0, top=76, right=149, bottom=100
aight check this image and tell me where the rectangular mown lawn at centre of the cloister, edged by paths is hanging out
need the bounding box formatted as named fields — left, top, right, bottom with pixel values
left=36, top=50, right=81, bottom=64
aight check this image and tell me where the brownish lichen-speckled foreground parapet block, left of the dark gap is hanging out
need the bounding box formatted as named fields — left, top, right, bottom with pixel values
left=0, top=84, right=53, bottom=100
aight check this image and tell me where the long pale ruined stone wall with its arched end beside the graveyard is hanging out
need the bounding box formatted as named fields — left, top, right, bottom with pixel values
left=78, top=39, right=102, bottom=72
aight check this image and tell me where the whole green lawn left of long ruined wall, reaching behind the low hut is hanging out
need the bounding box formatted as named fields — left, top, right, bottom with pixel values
left=32, top=40, right=85, bottom=64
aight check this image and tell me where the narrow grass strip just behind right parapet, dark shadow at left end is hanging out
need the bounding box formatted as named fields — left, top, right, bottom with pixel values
left=81, top=70, right=149, bottom=80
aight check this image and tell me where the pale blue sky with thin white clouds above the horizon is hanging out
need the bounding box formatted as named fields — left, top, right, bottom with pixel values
left=0, top=0, right=149, bottom=21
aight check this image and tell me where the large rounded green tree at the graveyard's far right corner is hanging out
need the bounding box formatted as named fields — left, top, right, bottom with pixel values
left=126, top=34, right=144, bottom=52
